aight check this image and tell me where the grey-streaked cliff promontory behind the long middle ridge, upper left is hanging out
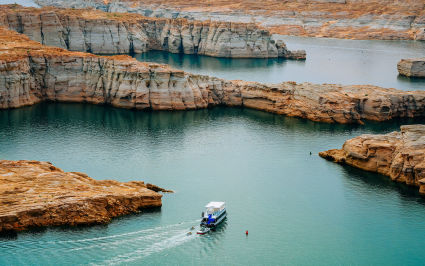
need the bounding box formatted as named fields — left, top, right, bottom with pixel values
left=0, top=5, right=305, bottom=59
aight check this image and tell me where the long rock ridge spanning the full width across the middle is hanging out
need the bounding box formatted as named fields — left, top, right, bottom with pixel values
left=0, top=27, right=425, bottom=123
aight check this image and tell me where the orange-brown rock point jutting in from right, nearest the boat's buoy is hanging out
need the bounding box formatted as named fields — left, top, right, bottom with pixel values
left=319, top=125, right=425, bottom=195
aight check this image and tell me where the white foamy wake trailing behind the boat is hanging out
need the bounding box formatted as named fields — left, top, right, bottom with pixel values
left=0, top=219, right=199, bottom=265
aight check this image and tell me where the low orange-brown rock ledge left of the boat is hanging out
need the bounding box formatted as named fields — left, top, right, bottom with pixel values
left=0, top=160, right=162, bottom=233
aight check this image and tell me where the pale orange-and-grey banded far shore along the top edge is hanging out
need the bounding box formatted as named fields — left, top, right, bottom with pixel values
left=36, top=0, right=425, bottom=40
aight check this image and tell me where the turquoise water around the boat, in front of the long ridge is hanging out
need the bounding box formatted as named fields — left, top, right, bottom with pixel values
left=0, top=103, right=425, bottom=265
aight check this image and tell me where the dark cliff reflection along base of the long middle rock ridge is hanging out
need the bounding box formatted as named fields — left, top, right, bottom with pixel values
left=0, top=102, right=425, bottom=136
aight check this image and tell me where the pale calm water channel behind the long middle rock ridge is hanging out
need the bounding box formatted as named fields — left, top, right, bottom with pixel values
left=135, top=36, right=425, bottom=90
